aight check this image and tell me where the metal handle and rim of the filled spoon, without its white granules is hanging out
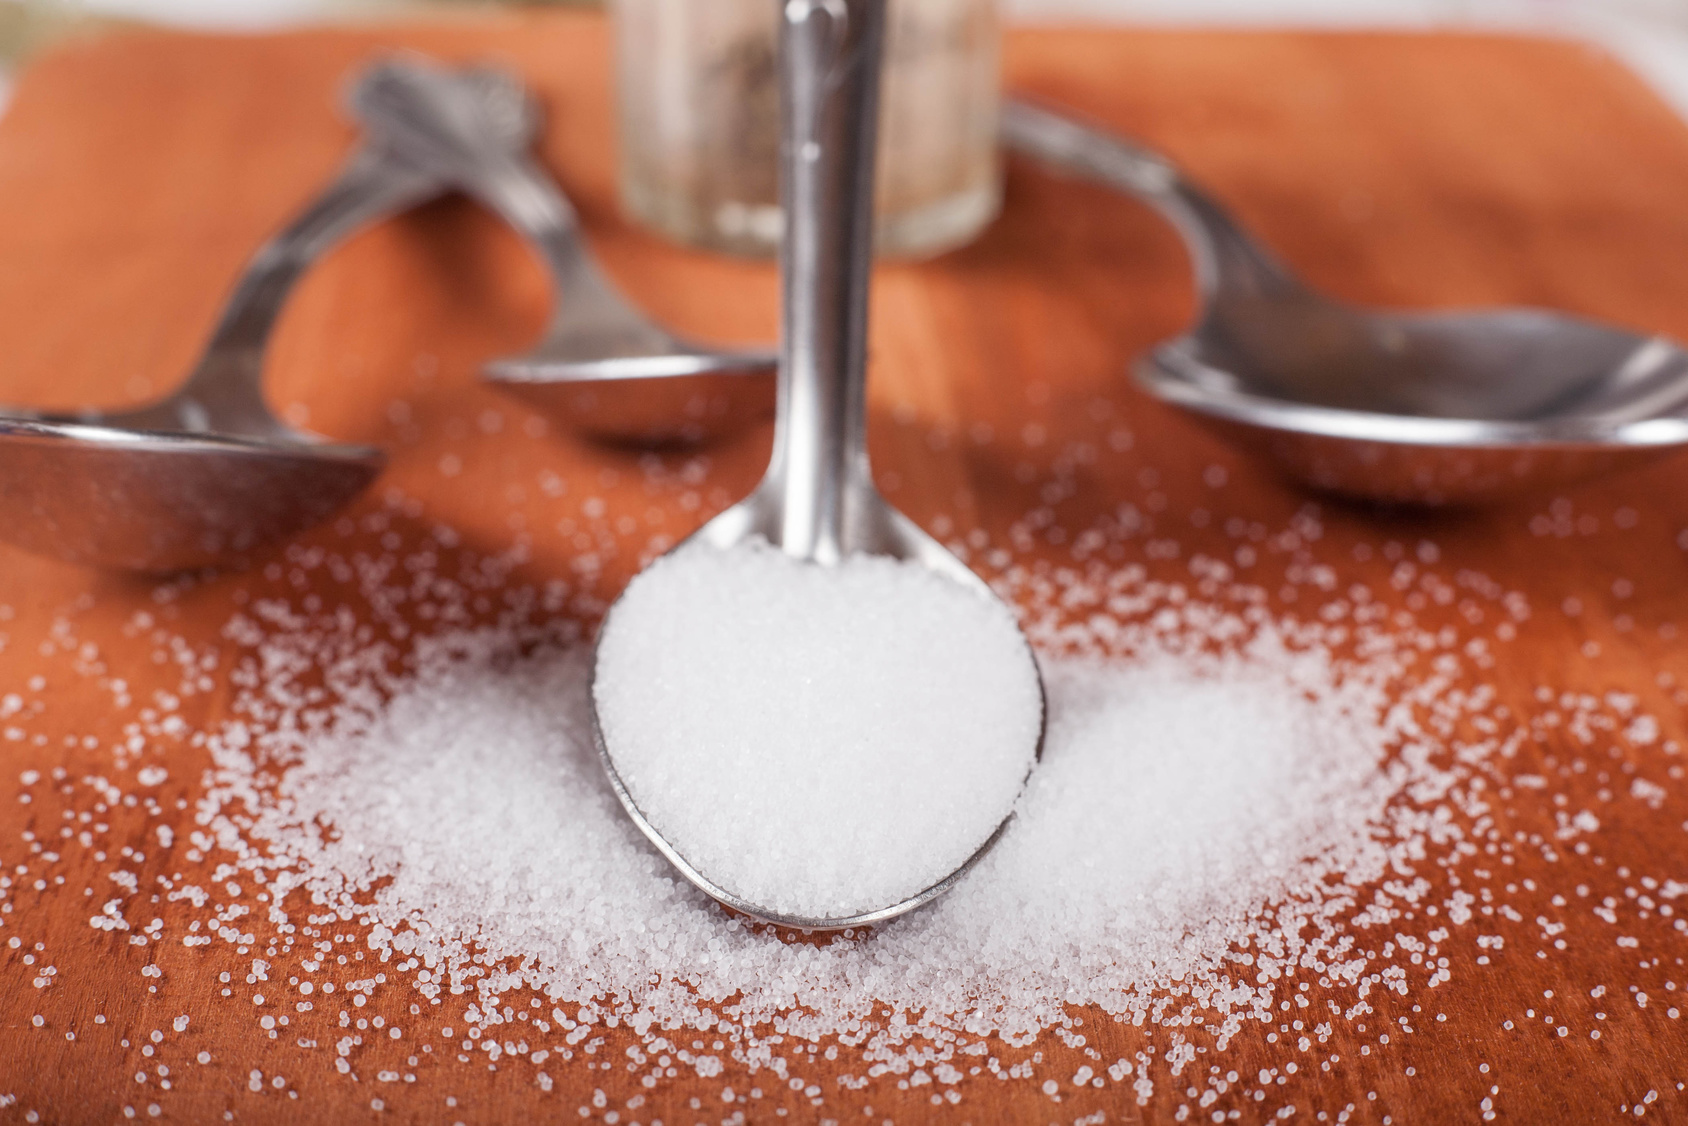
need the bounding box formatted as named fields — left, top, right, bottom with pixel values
left=592, top=0, right=1041, bottom=930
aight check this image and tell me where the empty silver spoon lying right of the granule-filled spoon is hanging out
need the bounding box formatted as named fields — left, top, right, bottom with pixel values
left=1001, top=101, right=1688, bottom=505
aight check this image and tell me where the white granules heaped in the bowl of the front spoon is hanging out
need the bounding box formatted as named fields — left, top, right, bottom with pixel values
left=592, top=542, right=1043, bottom=918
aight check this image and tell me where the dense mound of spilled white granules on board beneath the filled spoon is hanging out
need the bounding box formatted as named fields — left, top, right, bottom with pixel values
left=203, top=617, right=1413, bottom=1052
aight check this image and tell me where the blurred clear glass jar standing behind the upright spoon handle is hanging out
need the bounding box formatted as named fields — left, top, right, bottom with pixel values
left=613, top=0, right=1003, bottom=257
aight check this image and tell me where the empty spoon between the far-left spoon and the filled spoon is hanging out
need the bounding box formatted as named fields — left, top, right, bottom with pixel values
left=365, top=56, right=778, bottom=444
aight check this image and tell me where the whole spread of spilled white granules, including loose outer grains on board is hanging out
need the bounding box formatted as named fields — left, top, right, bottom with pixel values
left=0, top=476, right=1688, bottom=1123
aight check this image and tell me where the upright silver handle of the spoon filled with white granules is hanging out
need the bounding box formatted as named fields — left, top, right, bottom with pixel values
left=760, top=0, right=886, bottom=562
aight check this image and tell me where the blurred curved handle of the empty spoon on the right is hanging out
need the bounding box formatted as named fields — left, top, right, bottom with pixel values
left=999, top=98, right=1301, bottom=299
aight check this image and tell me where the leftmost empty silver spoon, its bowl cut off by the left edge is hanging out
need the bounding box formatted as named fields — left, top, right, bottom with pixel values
left=0, top=69, right=465, bottom=571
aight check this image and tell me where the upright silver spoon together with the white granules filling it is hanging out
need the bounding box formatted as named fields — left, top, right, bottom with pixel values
left=592, top=0, right=1043, bottom=930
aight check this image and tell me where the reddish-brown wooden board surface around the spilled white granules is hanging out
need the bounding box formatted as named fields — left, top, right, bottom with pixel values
left=0, top=14, right=1688, bottom=1126
